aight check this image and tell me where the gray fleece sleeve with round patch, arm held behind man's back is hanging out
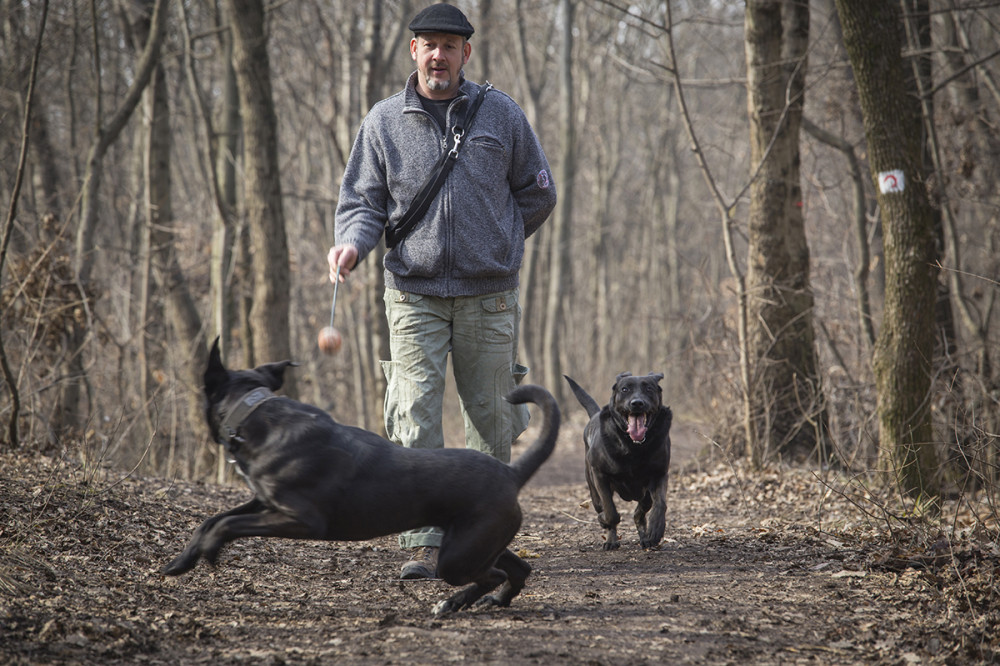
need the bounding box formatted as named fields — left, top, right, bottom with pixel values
left=510, top=108, right=556, bottom=238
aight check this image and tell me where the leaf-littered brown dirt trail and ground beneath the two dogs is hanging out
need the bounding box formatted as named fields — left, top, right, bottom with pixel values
left=0, top=424, right=1000, bottom=666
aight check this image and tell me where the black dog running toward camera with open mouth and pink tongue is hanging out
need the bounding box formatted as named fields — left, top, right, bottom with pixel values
left=563, top=372, right=673, bottom=550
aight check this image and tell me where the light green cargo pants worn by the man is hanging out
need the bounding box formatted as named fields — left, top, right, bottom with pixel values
left=382, top=289, right=528, bottom=548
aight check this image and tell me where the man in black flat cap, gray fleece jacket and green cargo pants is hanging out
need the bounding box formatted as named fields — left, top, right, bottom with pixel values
left=327, top=3, right=556, bottom=579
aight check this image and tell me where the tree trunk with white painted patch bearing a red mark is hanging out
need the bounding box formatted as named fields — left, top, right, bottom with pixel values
left=836, top=0, right=940, bottom=497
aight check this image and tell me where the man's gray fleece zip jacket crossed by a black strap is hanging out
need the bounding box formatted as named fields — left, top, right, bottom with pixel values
left=335, top=72, right=556, bottom=297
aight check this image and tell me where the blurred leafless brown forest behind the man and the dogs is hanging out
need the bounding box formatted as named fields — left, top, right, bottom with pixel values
left=0, top=0, right=1000, bottom=500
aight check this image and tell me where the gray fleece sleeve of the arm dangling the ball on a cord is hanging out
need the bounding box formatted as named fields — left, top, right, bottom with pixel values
left=334, top=115, right=388, bottom=262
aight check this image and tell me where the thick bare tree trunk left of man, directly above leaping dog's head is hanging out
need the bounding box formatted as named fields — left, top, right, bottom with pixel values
left=225, top=0, right=297, bottom=396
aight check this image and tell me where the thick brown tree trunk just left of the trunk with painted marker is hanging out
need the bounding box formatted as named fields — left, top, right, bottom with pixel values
left=745, top=0, right=827, bottom=464
